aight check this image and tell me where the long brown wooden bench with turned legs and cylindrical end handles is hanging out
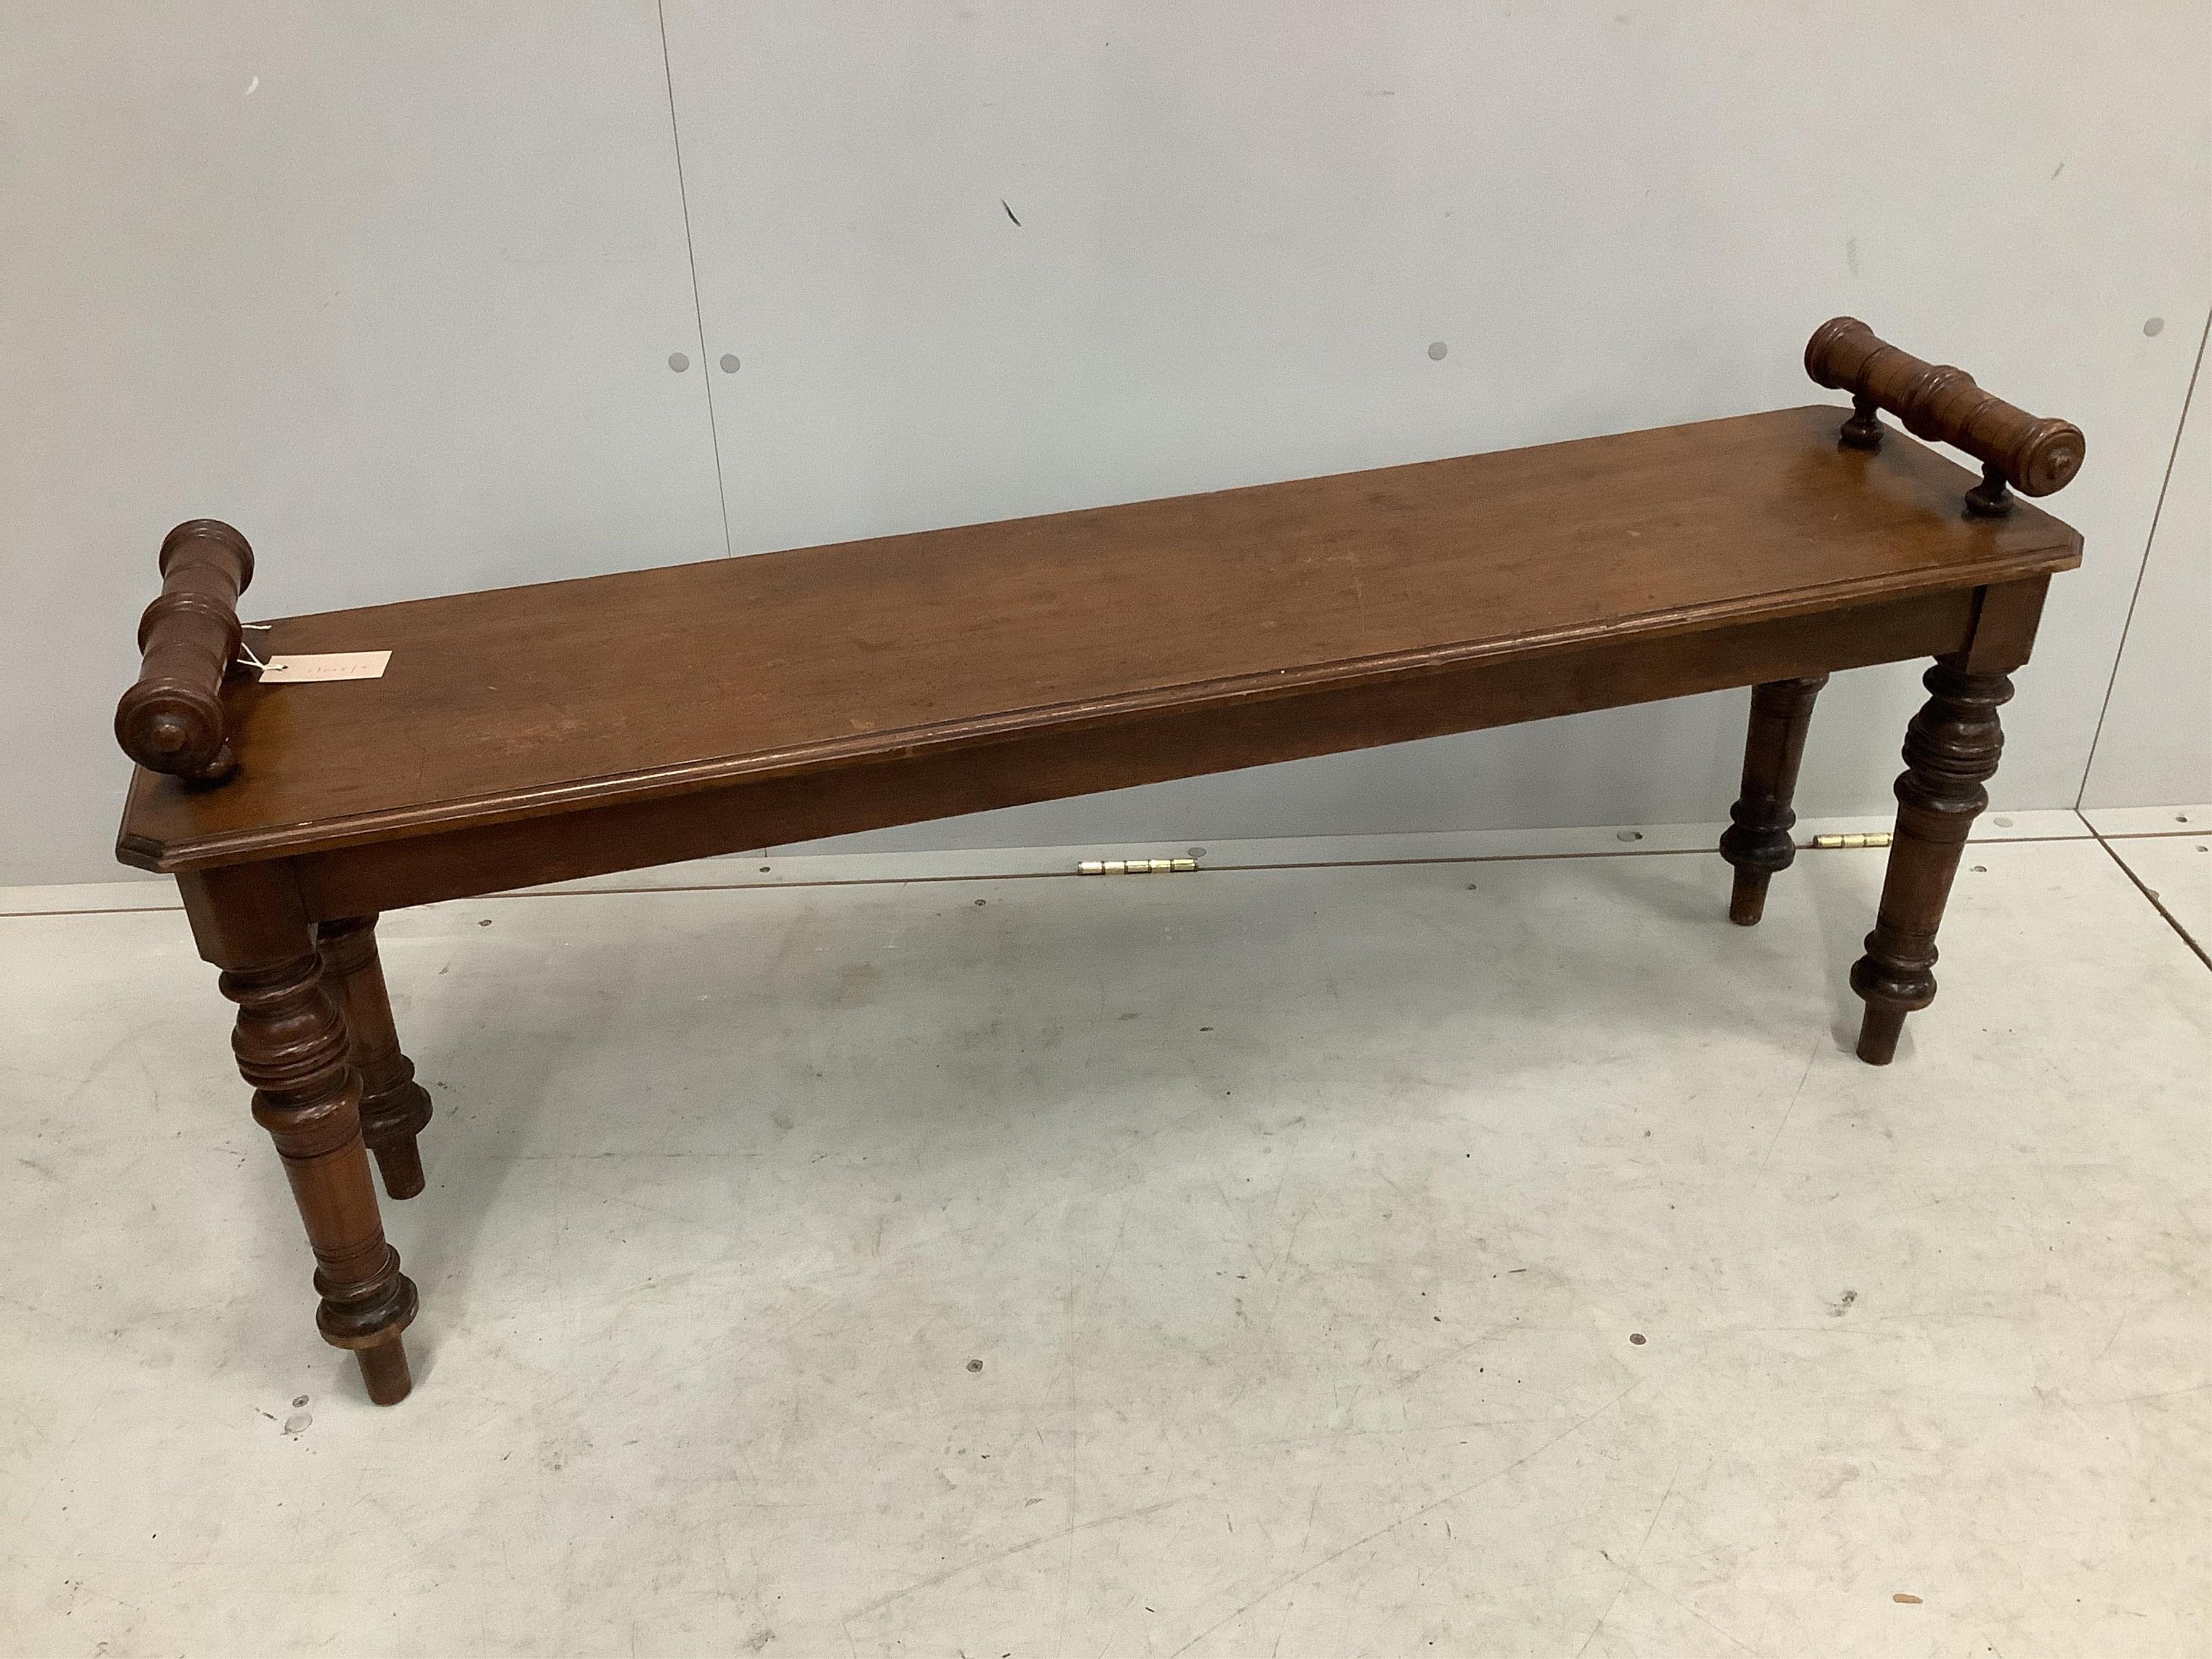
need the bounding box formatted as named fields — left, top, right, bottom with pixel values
left=115, top=319, right=2081, bottom=1405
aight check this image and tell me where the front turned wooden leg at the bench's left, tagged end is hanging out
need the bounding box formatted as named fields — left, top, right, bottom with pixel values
left=177, top=865, right=416, bottom=1405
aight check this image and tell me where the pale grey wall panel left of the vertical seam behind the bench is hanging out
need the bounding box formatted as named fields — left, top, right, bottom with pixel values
left=0, top=0, right=723, bottom=882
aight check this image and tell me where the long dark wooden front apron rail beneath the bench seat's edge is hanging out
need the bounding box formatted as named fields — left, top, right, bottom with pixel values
left=283, top=589, right=1995, bottom=918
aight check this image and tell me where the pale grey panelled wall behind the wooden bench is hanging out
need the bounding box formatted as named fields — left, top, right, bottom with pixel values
left=0, top=0, right=2212, bottom=880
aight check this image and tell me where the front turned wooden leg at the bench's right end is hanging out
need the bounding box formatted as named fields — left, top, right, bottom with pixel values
left=1851, top=657, right=2013, bottom=1066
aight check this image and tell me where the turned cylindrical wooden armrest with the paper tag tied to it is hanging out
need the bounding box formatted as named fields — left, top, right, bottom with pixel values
left=115, top=517, right=254, bottom=781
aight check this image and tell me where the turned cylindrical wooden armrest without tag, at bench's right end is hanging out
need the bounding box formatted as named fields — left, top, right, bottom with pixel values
left=1805, top=316, right=2081, bottom=496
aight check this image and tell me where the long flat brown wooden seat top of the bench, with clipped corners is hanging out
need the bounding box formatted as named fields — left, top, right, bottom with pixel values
left=119, top=405, right=2081, bottom=869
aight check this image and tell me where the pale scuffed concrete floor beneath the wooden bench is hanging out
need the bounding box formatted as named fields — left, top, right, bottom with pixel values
left=0, top=814, right=2212, bottom=1659
